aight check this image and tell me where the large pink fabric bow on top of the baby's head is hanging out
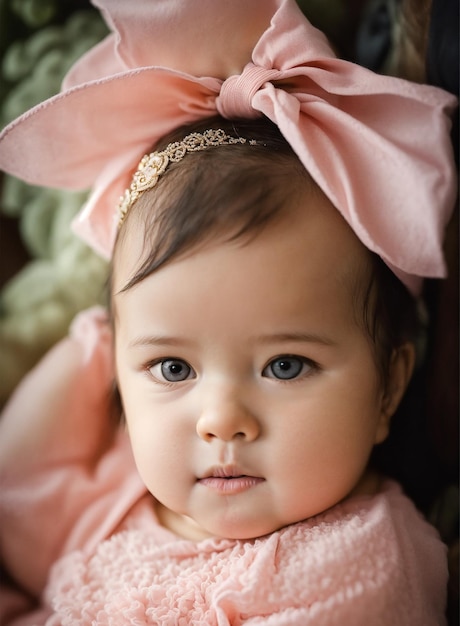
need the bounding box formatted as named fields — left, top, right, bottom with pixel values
left=0, top=0, right=456, bottom=294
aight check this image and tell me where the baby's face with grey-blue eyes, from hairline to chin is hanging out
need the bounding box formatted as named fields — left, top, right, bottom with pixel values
left=114, top=188, right=389, bottom=539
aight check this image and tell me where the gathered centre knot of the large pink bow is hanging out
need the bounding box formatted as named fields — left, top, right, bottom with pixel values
left=216, top=63, right=280, bottom=119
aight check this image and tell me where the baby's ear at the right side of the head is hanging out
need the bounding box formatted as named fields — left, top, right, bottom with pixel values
left=375, top=342, right=415, bottom=443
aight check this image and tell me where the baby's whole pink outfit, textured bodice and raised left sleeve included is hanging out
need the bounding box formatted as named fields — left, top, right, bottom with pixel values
left=0, top=310, right=447, bottom=626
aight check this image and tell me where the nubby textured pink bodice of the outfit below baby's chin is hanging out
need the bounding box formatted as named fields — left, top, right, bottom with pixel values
left=43, top=484, right=445, bottom=626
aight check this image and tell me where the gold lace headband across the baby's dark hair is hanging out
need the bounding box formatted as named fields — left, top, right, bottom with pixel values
left=118, top=128, right=257, bottom=226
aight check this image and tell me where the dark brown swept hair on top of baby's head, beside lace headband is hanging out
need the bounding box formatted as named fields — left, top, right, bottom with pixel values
left=115, top=118, right=314, bottom=289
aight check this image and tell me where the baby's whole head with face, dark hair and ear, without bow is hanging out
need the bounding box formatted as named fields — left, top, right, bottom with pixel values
left=111, top=120, right=414, bottom=539
